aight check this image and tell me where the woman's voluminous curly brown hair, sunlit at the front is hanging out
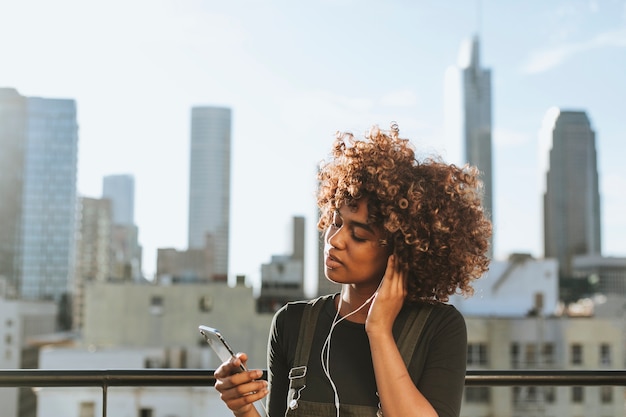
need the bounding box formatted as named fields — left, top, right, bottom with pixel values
left=317, top=123, right=491, bottom=302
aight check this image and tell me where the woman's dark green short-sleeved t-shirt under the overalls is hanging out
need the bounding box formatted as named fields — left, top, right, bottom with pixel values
left=268, top=297, right=467, bottom=417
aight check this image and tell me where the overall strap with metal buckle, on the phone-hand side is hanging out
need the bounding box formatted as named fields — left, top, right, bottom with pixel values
left=287, top=296, right=331, bottom=409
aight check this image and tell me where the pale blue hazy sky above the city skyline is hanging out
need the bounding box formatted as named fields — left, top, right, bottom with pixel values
left=0, top=0, right=626, bottom=289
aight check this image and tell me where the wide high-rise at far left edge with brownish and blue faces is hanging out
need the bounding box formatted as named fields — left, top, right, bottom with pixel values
left=0, top=88, right=78, bottom=308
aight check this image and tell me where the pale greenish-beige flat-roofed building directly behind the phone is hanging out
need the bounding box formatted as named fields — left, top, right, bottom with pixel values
left=82, top=281, right=272, bottom=368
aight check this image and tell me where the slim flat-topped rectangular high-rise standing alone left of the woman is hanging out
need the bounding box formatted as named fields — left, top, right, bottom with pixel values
left=188, top=107, right=231, bottom=281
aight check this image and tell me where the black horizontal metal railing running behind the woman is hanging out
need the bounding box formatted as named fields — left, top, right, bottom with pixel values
left=0, top=369, right=626, bottom=417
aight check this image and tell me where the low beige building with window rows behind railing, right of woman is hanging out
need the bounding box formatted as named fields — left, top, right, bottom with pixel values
left=461, top=316, right=624, bottom=417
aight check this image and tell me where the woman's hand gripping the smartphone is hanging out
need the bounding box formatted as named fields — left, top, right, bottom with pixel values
left=214, top=353, right=269, bottom=416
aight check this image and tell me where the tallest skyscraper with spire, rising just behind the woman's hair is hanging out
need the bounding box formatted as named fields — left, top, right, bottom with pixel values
left=445, top=37, right=493, bottom=253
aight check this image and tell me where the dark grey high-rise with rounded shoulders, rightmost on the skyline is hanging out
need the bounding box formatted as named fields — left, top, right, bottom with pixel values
left=542, top=109, right=601, bottom=277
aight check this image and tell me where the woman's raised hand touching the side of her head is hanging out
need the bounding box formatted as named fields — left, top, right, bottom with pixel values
left=365, top=255, right=407, bottom=333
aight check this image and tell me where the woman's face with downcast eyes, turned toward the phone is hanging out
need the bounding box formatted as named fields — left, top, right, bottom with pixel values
left=324, top=199, right=390, bottom=286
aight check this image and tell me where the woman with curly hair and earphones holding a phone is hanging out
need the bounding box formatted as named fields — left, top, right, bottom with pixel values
left=215, top=124, right=491, bottom=417
